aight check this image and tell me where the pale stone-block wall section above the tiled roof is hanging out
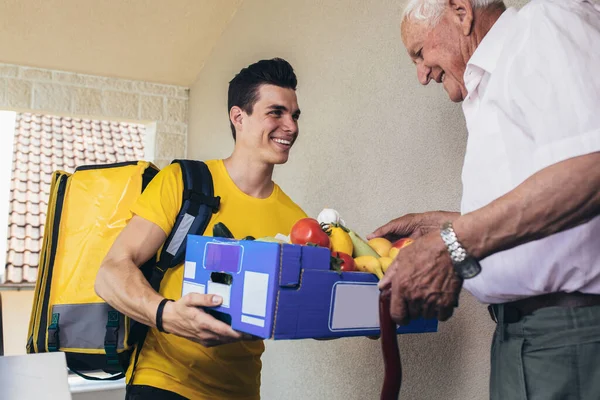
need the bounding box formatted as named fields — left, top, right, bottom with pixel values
left=0, top=63, right=189, bottom=167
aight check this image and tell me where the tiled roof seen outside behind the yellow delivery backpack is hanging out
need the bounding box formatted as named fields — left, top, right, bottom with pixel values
left=5, top=113, right=144, bottom=283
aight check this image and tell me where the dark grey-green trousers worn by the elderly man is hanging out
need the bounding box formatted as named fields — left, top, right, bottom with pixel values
left=490, top=306, right=600, bottom=400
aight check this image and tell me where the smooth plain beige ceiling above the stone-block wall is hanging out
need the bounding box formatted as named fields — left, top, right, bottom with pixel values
left=0, top=0, right=243, bottom=86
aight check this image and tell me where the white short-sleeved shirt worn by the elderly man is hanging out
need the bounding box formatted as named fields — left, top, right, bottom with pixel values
left=461, top=0, right=600, bottom=303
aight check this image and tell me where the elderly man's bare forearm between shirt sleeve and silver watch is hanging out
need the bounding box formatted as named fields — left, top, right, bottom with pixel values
left=454, top=152, right=600, bottom=259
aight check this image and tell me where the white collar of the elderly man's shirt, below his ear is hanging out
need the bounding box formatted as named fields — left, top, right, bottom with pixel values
left=465, top=7, right=517, bottom=74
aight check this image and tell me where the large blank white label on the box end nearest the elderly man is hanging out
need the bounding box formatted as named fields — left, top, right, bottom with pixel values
left=329, top=282, right=379, bottom=331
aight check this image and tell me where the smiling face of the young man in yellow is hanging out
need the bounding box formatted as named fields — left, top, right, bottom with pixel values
left=236, top=84, right=300, bottom=164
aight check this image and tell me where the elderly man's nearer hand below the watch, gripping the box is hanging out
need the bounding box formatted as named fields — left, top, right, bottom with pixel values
left=379, top=231, right=462, bottom=325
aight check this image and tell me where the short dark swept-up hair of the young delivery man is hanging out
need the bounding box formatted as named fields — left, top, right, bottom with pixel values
left=227, top=58, right=298, bottom=140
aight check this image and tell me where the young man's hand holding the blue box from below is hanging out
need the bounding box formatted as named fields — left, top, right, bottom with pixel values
left=163, top=293, right=256, bottom=347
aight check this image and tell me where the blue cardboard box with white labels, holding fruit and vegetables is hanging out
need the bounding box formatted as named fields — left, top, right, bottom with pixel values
left=182, top=235, right=437, bottom=340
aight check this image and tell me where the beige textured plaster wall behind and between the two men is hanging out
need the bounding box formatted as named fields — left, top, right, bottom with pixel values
left=188, top=0, right=525, bottom=400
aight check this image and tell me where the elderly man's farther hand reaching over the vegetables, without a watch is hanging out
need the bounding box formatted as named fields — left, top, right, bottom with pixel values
left=367, top=211, right=460, bottom=243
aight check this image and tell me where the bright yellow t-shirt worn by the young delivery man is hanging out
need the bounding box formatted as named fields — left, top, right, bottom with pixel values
left=127, top=160, right=306, bottom=400
